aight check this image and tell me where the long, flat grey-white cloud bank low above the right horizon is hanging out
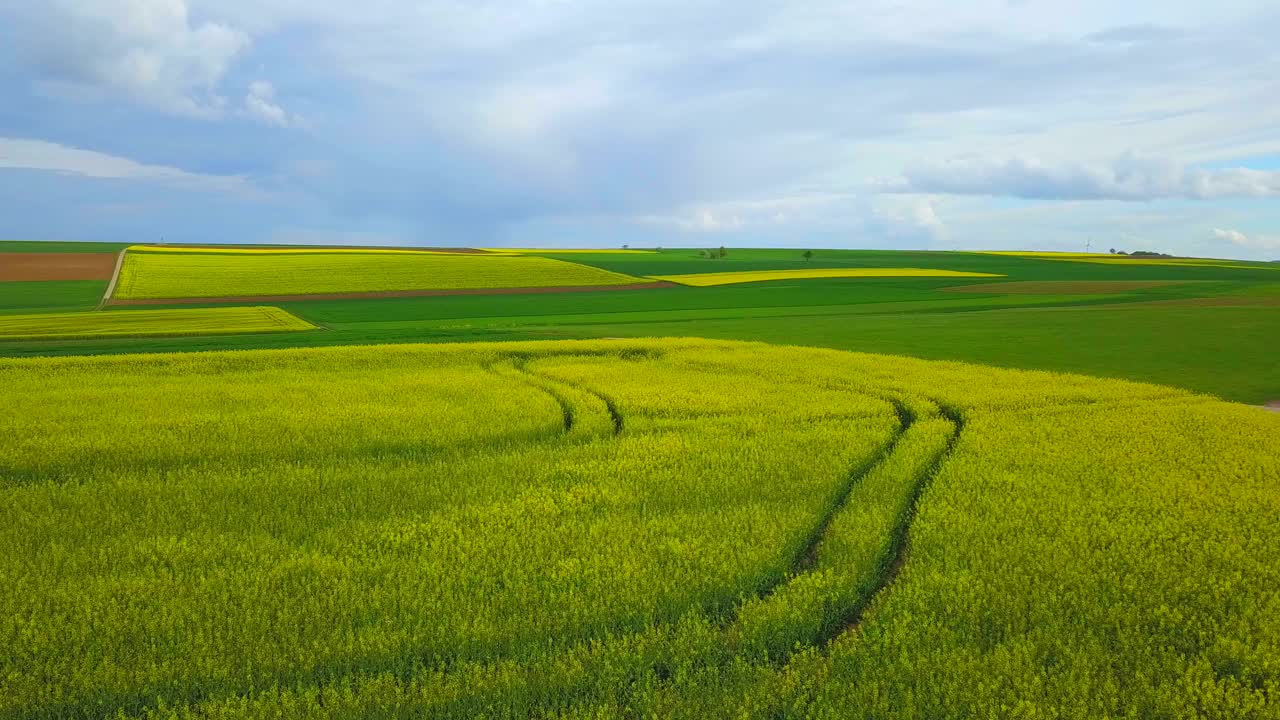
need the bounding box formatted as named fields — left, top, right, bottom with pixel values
left=874, top=154, right=1280, bottom=200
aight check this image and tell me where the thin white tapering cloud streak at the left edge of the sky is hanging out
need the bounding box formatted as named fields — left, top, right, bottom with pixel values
left=0, top=137, right=255, bottom=193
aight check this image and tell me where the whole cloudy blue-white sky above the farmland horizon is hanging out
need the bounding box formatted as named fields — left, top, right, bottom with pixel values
left=0, top=0, right=1280, bottom=259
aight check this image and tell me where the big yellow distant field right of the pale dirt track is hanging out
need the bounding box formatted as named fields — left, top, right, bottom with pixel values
left=113, top=247, right=645, bottom=300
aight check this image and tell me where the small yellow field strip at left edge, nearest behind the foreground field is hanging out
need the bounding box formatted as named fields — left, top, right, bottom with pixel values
left=0, top=307, right=316, bottom=341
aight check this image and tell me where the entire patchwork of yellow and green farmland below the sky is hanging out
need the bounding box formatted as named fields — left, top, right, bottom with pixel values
left=0, top=242, right=1280, bottom=720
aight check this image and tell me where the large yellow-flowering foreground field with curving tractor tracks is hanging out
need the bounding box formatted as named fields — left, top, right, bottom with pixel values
left=0, top=338, right=1280, bottom=719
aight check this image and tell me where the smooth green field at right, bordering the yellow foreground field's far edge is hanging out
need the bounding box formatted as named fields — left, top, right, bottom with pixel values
left=540, top=305, right=1280, bottom=404
